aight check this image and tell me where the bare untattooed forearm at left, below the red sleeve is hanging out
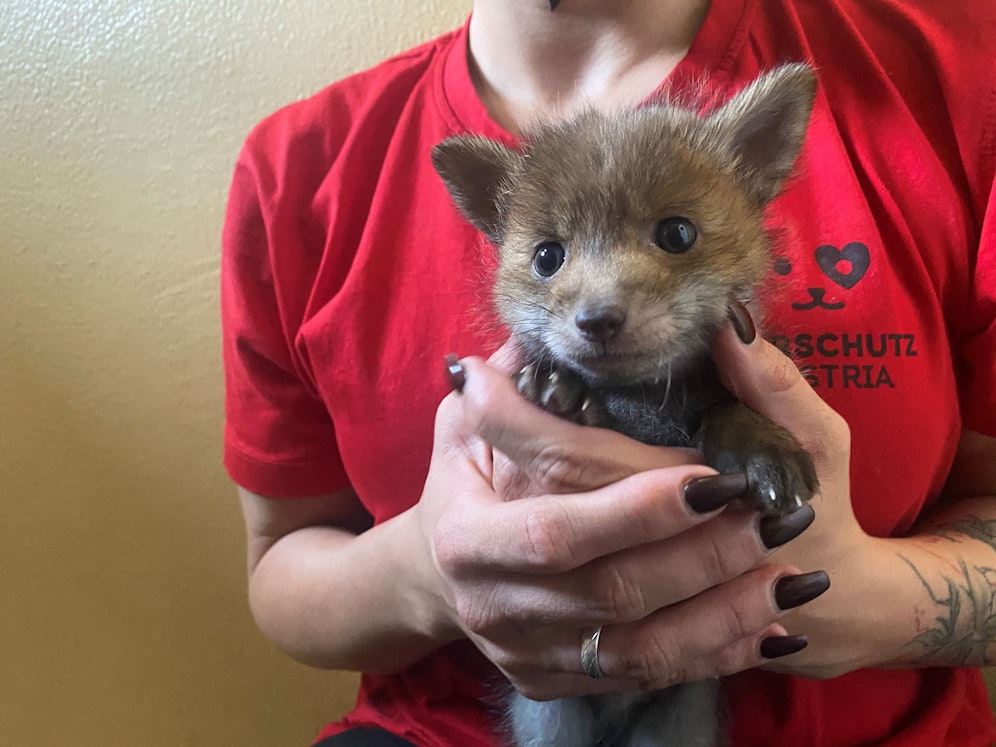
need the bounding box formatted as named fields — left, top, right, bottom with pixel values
left=249, top=514, right=459, bottom=673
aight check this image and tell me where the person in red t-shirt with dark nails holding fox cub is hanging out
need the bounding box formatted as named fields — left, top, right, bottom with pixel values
left=222, top=0, right=996, bottom=747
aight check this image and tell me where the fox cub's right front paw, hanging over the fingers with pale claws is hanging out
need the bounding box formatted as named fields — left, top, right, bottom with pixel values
left=700, top=403, right=819, bottom=515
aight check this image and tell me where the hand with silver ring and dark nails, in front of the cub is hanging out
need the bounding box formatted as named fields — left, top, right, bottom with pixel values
left=408, top=350, right=825, bottom=699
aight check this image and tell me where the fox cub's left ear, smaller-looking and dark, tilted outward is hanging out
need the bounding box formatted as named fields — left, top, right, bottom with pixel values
left=432, top=135, right=522, bottom=244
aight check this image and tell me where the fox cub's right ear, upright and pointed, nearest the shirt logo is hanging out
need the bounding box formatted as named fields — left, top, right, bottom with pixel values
left=707, top=63, right=816, bottom=205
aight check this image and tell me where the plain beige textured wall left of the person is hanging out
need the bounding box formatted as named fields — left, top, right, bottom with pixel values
left=0, top=0, right=469, bottom=747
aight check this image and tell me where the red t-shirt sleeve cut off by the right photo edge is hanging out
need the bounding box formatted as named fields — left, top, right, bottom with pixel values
left=959, top=169, right=996, bottom=436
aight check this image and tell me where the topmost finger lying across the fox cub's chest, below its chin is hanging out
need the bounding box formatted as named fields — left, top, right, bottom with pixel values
left=460, top=357, right=701, bottom=492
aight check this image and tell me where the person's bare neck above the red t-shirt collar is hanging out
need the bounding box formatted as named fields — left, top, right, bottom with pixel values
left=470, top=0, right=710, bottom=133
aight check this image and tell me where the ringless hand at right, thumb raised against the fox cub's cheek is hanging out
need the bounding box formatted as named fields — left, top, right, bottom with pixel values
left=714, top=306, right=889, bottom=677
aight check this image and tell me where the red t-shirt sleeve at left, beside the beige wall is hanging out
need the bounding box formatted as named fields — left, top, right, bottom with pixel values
left=221, top=144, right=349, bottom=498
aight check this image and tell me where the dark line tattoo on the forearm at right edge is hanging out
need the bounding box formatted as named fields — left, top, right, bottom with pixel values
left=899, top=517, right=996, bottom=666
